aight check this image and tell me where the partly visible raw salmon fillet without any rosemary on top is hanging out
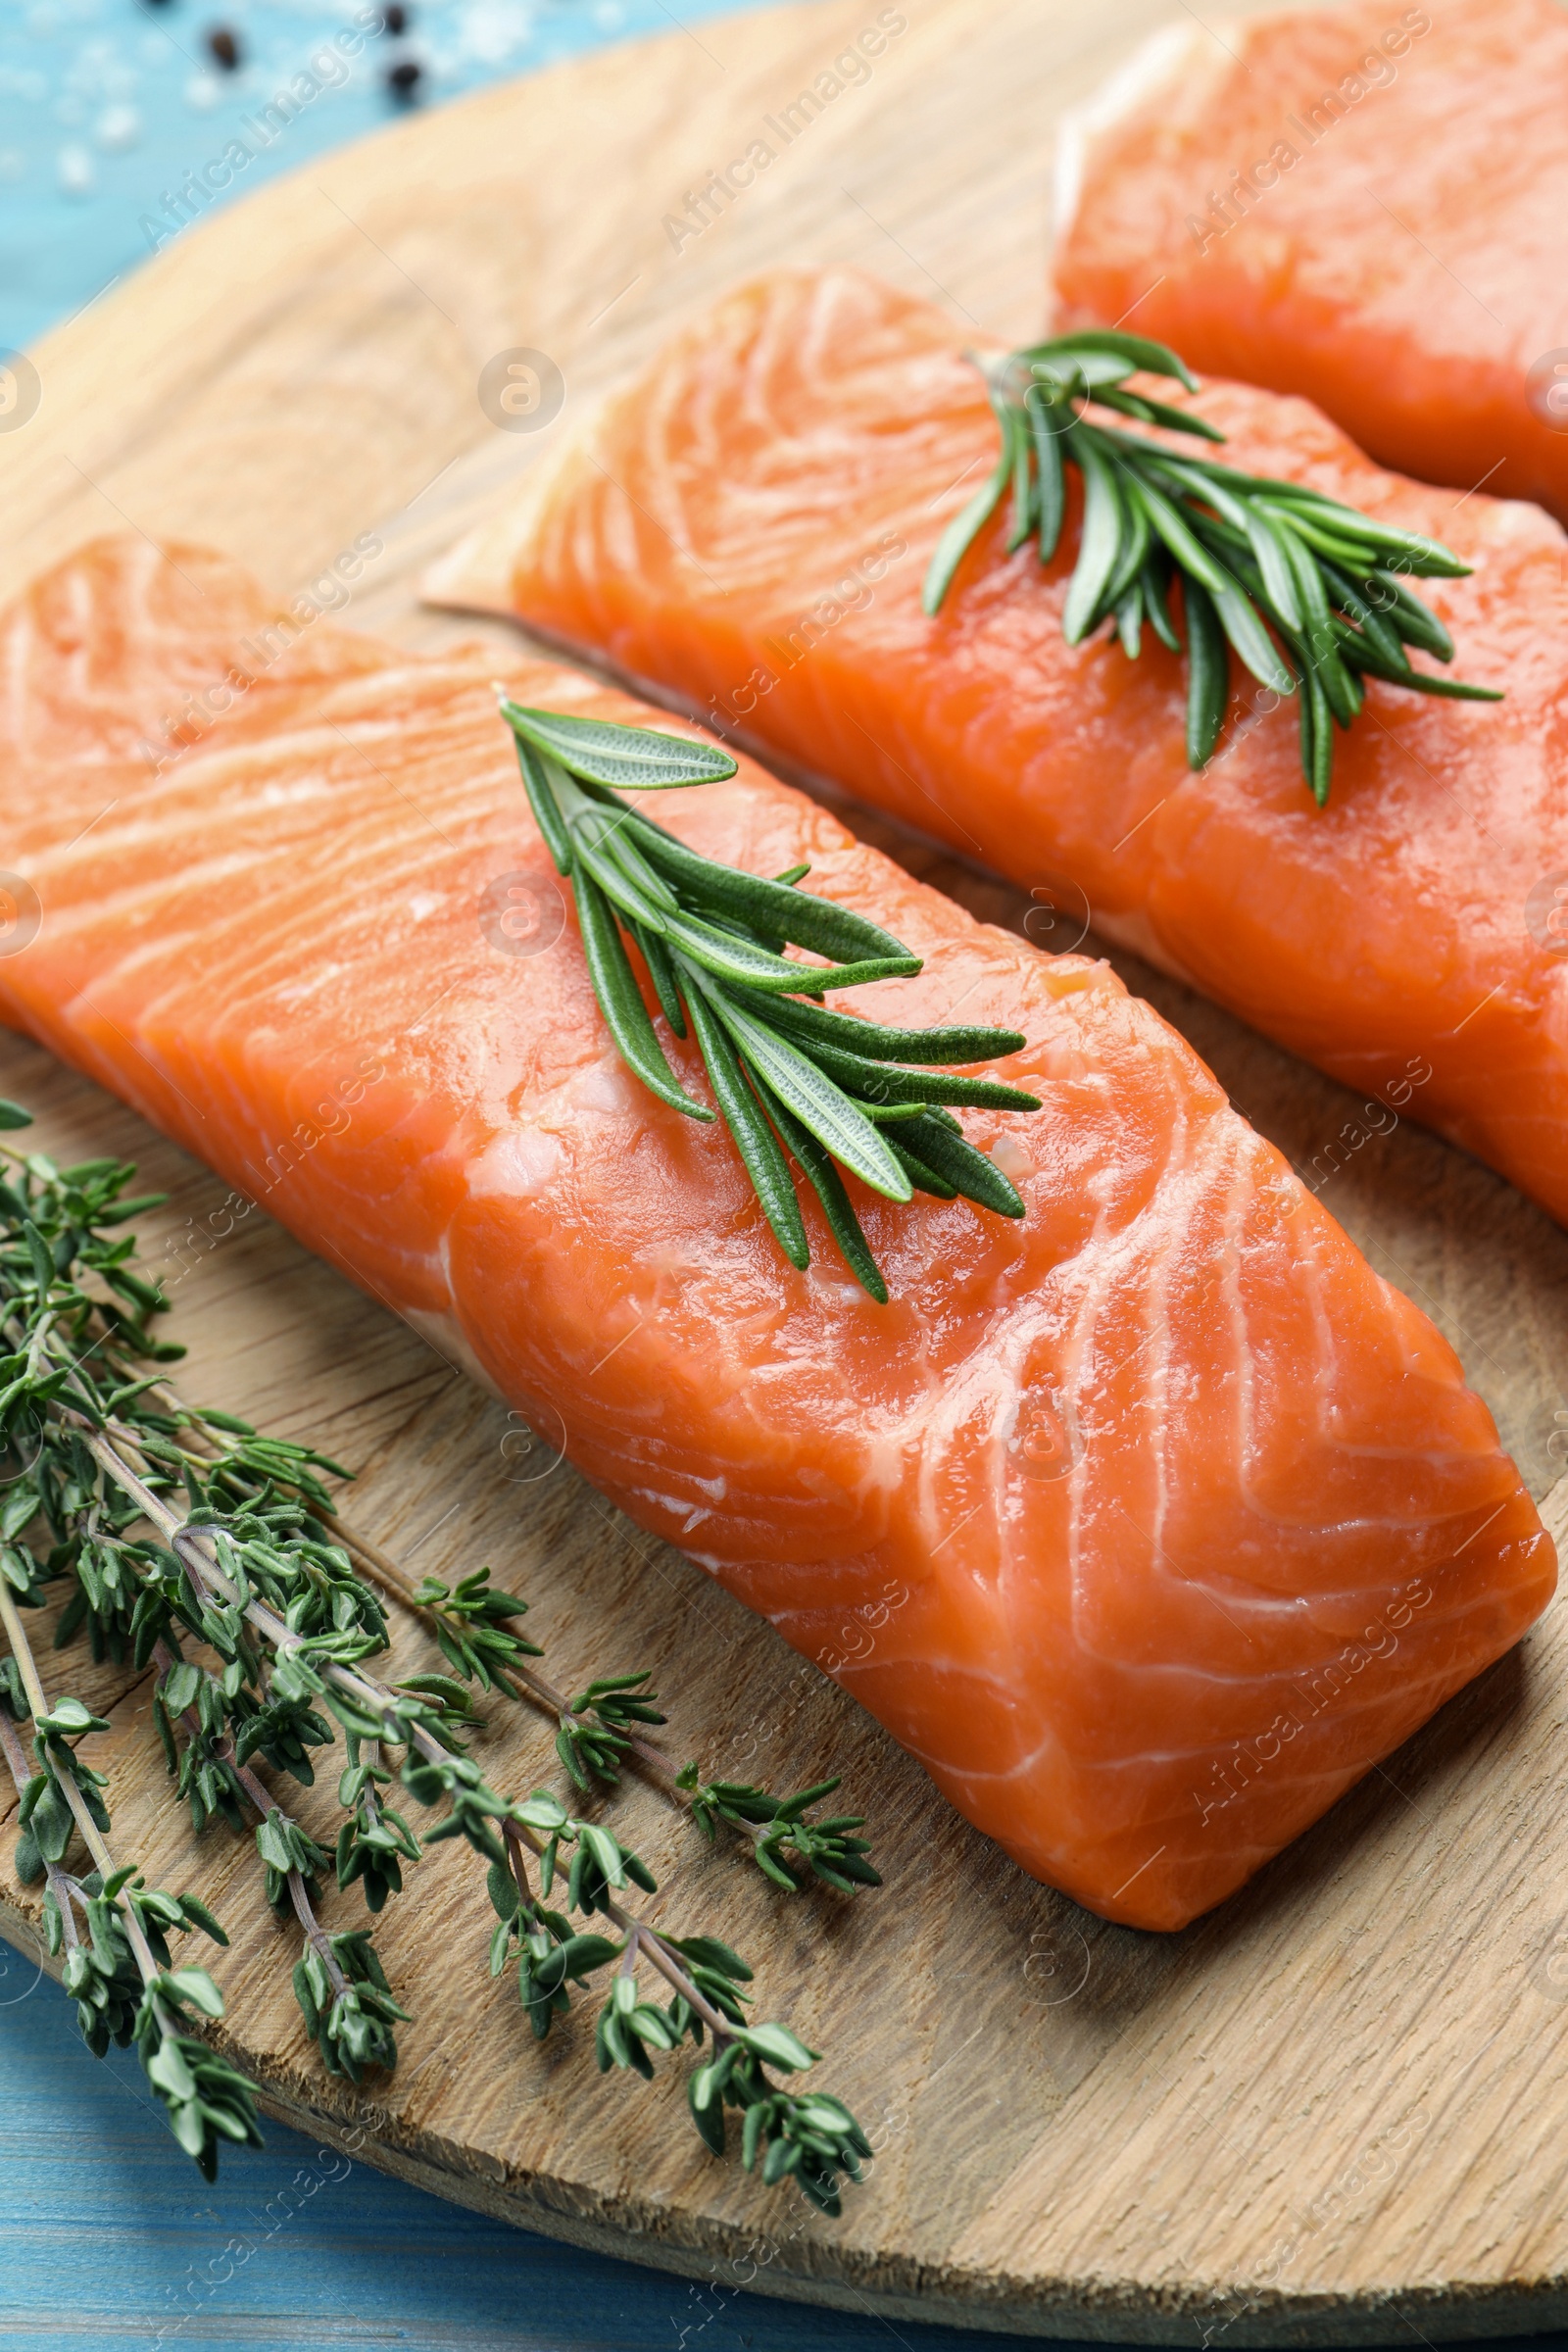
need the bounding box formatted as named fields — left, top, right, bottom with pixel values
left=1055, top=0, right=1568, bottom=517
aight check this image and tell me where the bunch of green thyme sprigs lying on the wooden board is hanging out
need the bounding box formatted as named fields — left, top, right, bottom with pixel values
left=0, top=1103, right=877, bottom=2211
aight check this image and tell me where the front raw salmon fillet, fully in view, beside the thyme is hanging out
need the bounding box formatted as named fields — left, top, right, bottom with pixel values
left=0, top=539, right=1554, bottom=1929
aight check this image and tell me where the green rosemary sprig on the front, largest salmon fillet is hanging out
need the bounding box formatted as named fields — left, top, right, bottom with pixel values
left=501, top=694, right=1039, bottom=1305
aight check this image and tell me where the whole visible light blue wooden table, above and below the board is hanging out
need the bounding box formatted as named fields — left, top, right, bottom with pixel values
left=0, top=0, right=1568, bottom=2352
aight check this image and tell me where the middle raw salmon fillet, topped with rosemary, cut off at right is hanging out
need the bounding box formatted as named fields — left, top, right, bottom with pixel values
left=432, top=270, right=1568, bottom=1221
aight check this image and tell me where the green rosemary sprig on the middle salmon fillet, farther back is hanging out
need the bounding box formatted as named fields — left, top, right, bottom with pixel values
left=924, top=327, right=1502, bottom=807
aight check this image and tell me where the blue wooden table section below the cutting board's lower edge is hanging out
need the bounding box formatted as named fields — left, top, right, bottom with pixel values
left=0, top=1945, right=1048, bottom=2352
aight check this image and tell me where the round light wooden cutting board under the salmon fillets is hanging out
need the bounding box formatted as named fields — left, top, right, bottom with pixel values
left=0, top=0, right=1568, bottom=2345
